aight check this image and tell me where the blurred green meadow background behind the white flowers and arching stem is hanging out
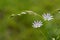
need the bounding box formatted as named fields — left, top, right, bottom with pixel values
left=0, top=0, right=60, bottom=40
